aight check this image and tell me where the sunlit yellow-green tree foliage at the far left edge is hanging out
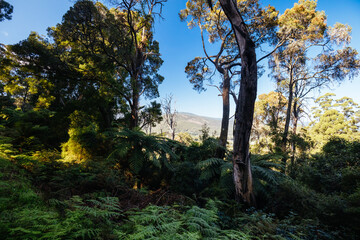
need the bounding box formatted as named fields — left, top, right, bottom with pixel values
left=0, top=32, right=55, bottom=110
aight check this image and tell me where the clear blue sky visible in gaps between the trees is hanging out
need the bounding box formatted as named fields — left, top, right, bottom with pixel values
left=0, top=0, right=360, bottom=117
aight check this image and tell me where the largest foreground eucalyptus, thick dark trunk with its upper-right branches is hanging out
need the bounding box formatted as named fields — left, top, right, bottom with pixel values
left=184, top=0, right=308, bottom=203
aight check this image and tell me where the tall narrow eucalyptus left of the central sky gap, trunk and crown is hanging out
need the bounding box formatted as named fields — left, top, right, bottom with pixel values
left=112, top=0, right=167, bottom=128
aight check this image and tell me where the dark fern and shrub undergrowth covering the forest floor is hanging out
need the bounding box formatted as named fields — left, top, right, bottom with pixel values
left=0, top=132, right=359, bottom=240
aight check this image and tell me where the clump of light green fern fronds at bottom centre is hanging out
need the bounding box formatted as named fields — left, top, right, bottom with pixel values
left=116, top=201, right=256, bottom=240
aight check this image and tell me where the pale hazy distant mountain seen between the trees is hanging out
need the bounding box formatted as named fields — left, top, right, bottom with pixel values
left=152, top=112, right=233, bottom=140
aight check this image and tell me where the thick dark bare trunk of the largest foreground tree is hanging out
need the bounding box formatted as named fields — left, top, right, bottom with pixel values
left=220, top=0, right=257, bottom=204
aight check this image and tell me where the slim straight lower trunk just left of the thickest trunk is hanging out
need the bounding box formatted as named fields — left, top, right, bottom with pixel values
left=217, top=70, right=230, bottom=158
